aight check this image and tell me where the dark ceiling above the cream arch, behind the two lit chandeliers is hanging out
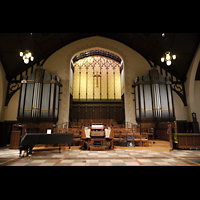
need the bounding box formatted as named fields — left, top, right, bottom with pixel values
left=0, top=33, right=200, bottom=82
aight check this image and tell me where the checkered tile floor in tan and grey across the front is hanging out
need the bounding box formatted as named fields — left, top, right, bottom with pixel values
left=0, top=148, right=200, bottom=166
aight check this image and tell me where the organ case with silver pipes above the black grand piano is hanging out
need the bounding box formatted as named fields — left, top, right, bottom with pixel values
left=17, top=66, right=60, bottom=133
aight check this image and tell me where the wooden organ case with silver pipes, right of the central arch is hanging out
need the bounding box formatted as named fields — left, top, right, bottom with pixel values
left=134, top=68, right=176, bottom=140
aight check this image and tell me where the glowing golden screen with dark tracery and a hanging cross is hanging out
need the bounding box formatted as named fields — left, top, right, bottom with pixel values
left=73, top=56, right=121, bottom=100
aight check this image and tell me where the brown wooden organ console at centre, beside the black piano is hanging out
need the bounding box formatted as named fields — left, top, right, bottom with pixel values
left=81, top=124, right=114, bottom=150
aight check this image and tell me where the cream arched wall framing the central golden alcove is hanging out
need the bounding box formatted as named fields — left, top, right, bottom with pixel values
left=43, top=36, right=151, bottom=124
